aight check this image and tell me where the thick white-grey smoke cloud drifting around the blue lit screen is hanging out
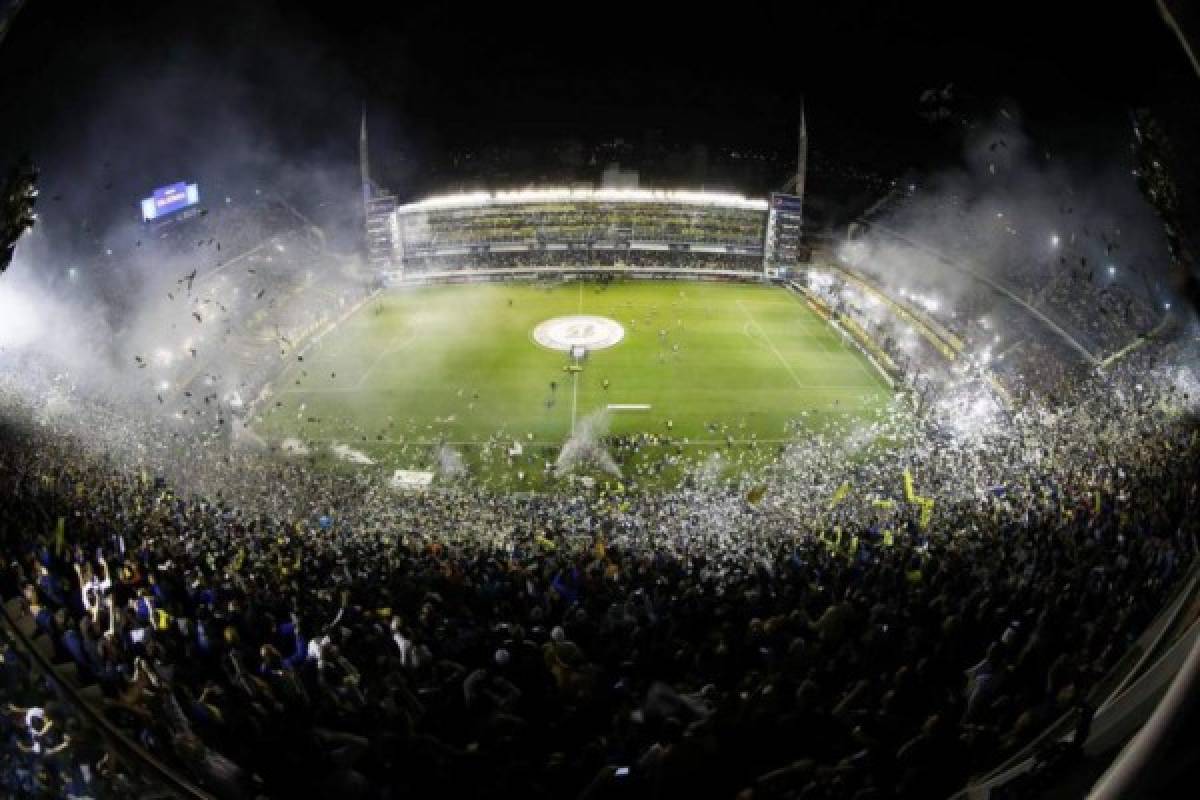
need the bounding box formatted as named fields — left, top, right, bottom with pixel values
left=0, top=4, right=376, bottom=424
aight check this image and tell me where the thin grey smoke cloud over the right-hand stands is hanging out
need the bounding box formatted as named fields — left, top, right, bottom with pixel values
left=839, top=108, right=1178, bottom=354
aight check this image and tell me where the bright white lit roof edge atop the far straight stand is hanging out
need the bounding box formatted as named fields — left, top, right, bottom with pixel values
left=397, top=188, right=767, bottom=213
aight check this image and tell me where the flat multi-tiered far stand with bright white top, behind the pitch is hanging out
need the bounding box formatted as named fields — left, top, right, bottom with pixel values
left=373, top=188, right=799, bottom=276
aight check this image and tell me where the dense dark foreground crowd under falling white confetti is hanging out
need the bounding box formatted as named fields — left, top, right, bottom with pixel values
left=0, top=302, right=1198, bottom=799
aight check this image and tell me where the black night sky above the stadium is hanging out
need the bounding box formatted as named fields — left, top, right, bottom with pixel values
left=0, top=0, right=1186, bottom=211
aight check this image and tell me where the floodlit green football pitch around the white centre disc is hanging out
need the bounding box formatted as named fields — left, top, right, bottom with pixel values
left=254, top=282, right=892, bottom=488
